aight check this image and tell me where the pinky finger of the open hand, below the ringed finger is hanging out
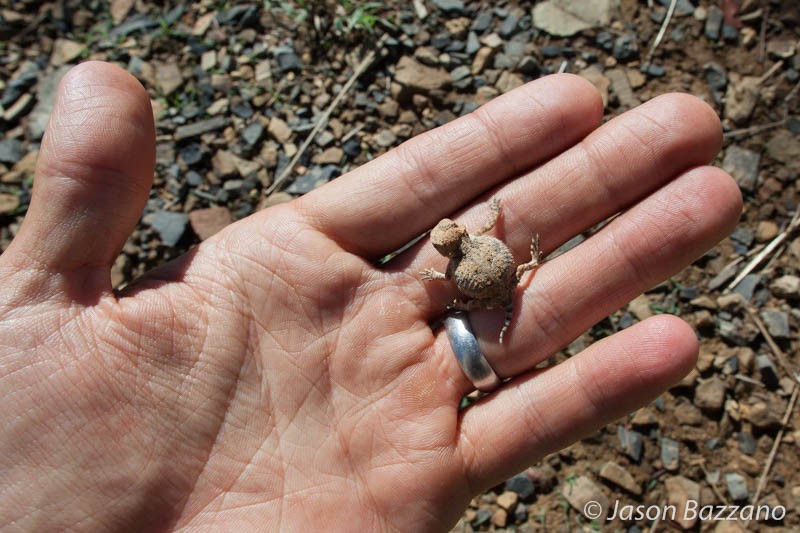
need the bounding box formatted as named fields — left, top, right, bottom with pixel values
left=458, top=315, right=698, bottom=491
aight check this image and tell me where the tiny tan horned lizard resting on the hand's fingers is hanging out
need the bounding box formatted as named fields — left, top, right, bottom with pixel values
left=420, top=198, right=540, bottom=344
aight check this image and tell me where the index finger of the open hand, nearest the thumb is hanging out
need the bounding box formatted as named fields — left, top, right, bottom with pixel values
left=296, top=74, right=603, bottom=259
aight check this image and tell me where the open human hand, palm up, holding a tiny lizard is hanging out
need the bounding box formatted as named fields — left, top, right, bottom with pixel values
left=0, top=63, right=741, bottom=531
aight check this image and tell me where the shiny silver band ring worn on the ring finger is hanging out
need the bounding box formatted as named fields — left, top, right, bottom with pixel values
left=444, top=311, right=500, bottom=392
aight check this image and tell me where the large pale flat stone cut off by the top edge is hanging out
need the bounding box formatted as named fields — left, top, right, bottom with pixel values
left=533, top=0, right=619, bottom=37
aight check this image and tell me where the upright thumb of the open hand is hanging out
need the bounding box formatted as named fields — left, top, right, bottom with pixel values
left=0, top=62, right=155, bottom=299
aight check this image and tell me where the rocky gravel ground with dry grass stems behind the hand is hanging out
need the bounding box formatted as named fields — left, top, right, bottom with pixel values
left=0, top=0, right=800, bottom=532
